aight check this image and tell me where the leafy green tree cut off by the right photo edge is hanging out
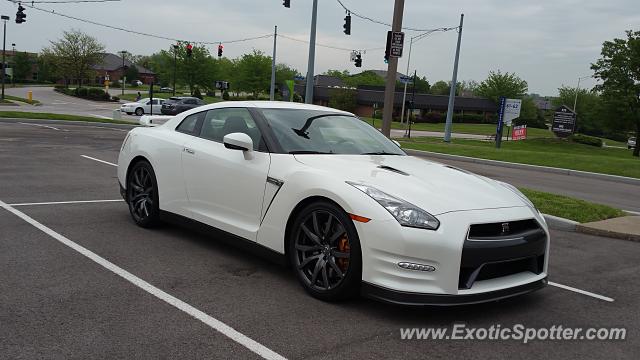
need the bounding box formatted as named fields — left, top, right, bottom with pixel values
left=591, top=30, right=640, bottom=156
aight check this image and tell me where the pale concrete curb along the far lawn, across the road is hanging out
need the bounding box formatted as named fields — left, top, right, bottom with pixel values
left=403, top=149, right=640, bottom=185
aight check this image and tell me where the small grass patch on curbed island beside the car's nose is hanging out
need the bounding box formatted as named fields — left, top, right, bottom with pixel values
left=520, top=188, right=626, bottom=223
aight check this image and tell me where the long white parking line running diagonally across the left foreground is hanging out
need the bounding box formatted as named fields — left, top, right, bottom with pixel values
left=0, top=200, right=285, bottom=360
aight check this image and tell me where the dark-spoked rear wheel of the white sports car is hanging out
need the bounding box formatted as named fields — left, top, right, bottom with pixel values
left=127, top=161, right=160, bottom=228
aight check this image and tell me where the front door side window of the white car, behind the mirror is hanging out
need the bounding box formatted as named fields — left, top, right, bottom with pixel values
left=200, top=108, right=267, bottom=151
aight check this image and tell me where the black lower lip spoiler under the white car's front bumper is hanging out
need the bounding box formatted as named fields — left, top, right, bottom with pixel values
left=361, top=277, right=547, bottom=306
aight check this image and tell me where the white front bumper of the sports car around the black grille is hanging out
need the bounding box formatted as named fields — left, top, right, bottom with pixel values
left=355, top=206, right=549, bottom=304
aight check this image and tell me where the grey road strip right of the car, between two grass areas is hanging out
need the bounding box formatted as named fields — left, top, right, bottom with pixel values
left=410, top=150, right=640, bottom=212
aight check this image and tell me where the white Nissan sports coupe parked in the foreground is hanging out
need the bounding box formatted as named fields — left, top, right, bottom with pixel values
left=118, top=102, right=549, bottom=305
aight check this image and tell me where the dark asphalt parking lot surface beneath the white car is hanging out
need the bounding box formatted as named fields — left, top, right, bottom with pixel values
left=0, top=121, right=640, bottom=359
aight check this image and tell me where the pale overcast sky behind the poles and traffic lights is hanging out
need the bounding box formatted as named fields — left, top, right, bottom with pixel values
left=0, top=0, right=640, bottom=96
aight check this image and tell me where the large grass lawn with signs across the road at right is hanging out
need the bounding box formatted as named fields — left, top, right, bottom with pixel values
left=397, top=137, right=640, bottom=178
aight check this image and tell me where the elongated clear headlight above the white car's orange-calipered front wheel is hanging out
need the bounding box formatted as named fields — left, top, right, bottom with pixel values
left=347, top=181, right=440, bottom=230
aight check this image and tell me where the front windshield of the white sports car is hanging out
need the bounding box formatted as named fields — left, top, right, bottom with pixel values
left=262, top=109, right=405, bottom=155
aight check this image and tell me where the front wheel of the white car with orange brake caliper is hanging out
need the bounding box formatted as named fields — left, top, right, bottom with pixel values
left=288, top=201, right=362, bottom=301
